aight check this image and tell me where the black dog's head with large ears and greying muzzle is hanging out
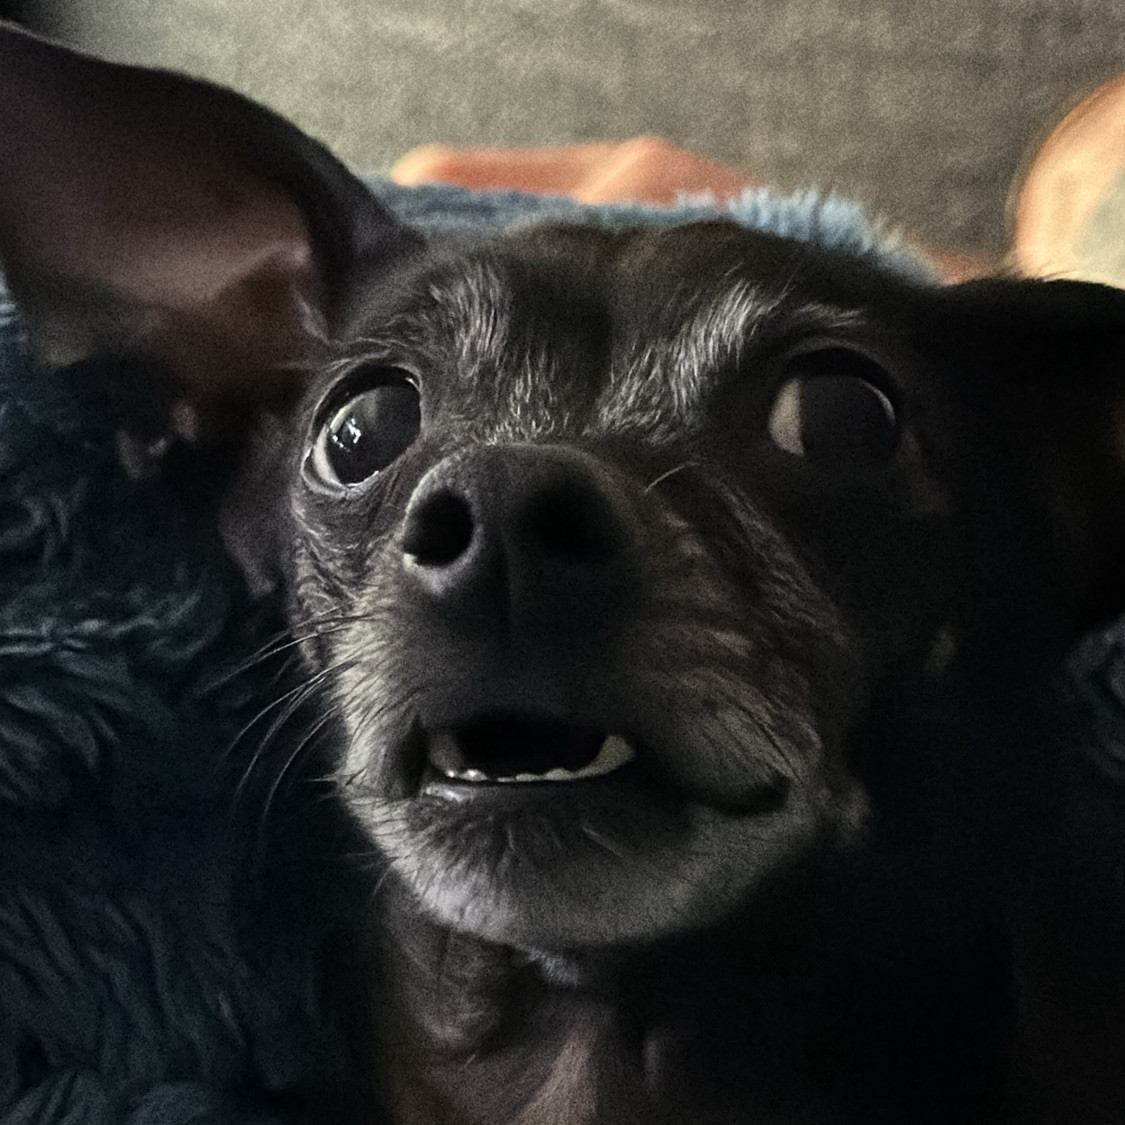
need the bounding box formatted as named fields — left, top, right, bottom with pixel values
left=0, top=32, right=1125, bottom=950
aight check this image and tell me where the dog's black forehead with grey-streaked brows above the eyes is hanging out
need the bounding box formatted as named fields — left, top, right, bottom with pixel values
left=328, top=223, right=909, bottom=439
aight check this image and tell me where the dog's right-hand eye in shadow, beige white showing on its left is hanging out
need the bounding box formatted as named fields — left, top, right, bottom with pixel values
left=768, top=348, right=899, bottom=469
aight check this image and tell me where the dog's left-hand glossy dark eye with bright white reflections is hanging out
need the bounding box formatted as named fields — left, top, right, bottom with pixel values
left=312, top=368, right=422, bottom=485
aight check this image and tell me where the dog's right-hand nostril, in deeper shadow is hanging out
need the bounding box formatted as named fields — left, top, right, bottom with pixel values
left=520, top=483, right=623, bottom=563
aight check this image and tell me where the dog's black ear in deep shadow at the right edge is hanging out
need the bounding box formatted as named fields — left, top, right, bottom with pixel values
left=925, top=279, right=1125, bottom=627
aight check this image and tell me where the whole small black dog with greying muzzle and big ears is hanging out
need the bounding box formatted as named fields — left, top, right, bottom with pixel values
left=0, top=24, right=1125, bottom=1125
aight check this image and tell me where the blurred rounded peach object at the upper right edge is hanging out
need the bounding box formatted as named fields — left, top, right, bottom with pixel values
left=1013, top=75, right=1125, bottom=286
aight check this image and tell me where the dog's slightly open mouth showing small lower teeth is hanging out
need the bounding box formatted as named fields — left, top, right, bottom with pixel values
left=424, top=714, right=637, bottom=795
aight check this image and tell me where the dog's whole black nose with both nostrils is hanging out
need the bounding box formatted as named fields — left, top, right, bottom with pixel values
left=403, top=446, right=639, bottom=627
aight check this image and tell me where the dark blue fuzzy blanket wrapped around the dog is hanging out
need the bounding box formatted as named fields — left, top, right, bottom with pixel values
left=0, top=183, right=1125, bottom=1125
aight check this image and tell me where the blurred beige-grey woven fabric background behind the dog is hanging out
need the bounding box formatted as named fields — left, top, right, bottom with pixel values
left=23, top=0, right=1125, bottom=251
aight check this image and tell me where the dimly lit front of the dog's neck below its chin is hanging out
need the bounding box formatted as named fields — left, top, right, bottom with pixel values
left=372, top=895, right=662, bottom=1125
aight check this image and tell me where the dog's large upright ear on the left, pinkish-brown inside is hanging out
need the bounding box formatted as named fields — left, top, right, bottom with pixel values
left=0, top=26, right=416, bottom=438
